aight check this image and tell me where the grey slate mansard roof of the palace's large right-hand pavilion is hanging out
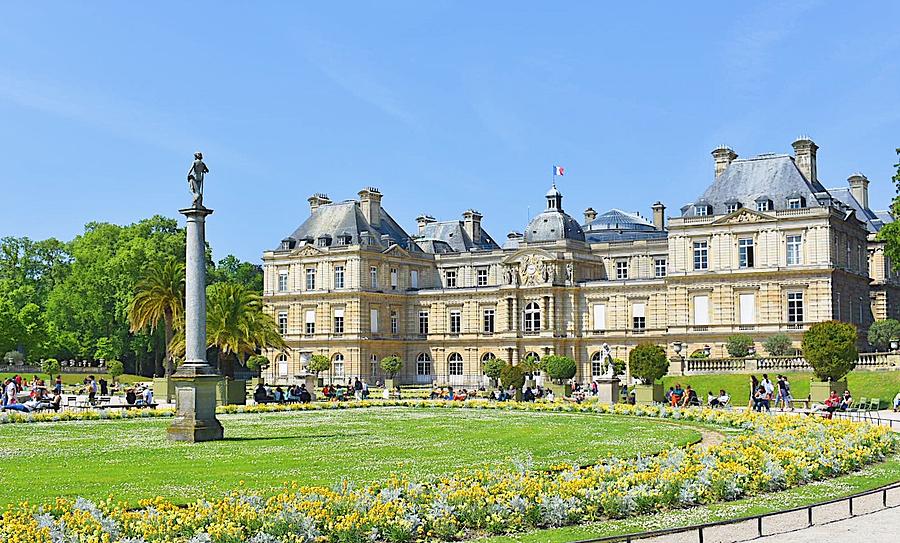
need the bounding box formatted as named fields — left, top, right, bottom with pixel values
left=682, top=153, right=828, bottom=217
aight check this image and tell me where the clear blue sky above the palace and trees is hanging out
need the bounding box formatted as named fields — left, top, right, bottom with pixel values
left=0, top=1, right=900, bottom=262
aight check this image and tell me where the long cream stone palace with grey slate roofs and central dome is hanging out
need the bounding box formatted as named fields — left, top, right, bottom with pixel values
left=263, top=137, right=900, bottom=386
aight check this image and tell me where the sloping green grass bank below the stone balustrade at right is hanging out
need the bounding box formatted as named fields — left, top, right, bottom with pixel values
left=663, top=371, right=900, bottom=406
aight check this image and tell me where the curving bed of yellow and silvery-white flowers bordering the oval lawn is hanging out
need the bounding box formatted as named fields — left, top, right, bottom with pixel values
left=0, top=401, right=897, bottom=543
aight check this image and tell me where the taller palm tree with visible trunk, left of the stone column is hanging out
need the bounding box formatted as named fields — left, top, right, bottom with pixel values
left=128, top=258, right=184, bottom=376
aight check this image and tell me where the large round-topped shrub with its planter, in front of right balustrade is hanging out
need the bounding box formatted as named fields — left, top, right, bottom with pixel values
left=803, top=321, right=859, bottom=402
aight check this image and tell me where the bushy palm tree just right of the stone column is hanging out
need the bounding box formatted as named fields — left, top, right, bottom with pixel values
left=172, top=283, right=286, bottom=376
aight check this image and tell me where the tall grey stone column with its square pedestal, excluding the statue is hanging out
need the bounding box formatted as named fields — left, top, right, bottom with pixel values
left=168, top=206, right=223, bottom=442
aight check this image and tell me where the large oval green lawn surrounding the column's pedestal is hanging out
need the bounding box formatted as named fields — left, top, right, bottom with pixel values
left=0, top=408, right=700, bottom=505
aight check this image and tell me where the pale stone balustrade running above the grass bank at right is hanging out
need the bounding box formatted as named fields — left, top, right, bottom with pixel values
left=669, top=353, right=900, bottom=375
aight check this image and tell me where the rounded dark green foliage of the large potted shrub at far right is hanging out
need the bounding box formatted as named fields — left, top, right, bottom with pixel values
left=803, top=321, right=859, bottom=381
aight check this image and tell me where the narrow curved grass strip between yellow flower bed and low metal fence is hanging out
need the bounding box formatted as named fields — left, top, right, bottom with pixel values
left=477, top=456, right=900, bottom=543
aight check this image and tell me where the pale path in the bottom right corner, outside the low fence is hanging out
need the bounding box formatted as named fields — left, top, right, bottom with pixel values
left=752, top=507, right=900, bottom=543
